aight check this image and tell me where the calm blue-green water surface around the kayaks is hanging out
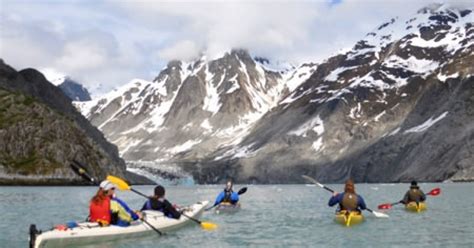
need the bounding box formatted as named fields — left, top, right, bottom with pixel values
left=0, top=183, right=474, bottom=247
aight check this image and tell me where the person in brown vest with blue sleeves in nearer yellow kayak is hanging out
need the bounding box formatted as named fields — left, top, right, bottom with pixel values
left=328, top=179, right=367, bottom=213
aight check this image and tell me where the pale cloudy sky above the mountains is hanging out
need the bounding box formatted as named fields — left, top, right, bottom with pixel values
left=0, top=0, right=474, bottom=94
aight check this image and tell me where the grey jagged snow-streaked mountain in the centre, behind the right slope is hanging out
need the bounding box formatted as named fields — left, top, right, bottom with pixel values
left=76, top=50, right=316, bottom=165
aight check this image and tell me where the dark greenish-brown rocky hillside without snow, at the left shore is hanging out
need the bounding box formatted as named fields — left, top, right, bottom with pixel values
left=0, top=60, right=150, bottom=185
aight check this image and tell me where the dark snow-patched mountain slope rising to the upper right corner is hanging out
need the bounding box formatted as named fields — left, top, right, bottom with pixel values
left=198, top=5, right=474, bottom=183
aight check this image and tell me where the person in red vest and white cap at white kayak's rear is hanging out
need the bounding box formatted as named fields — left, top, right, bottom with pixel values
left=89, top=180, right=141, bottom=226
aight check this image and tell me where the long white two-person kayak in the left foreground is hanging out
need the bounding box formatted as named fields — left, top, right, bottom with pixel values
left=30, top=201, right=209, bottom=248
